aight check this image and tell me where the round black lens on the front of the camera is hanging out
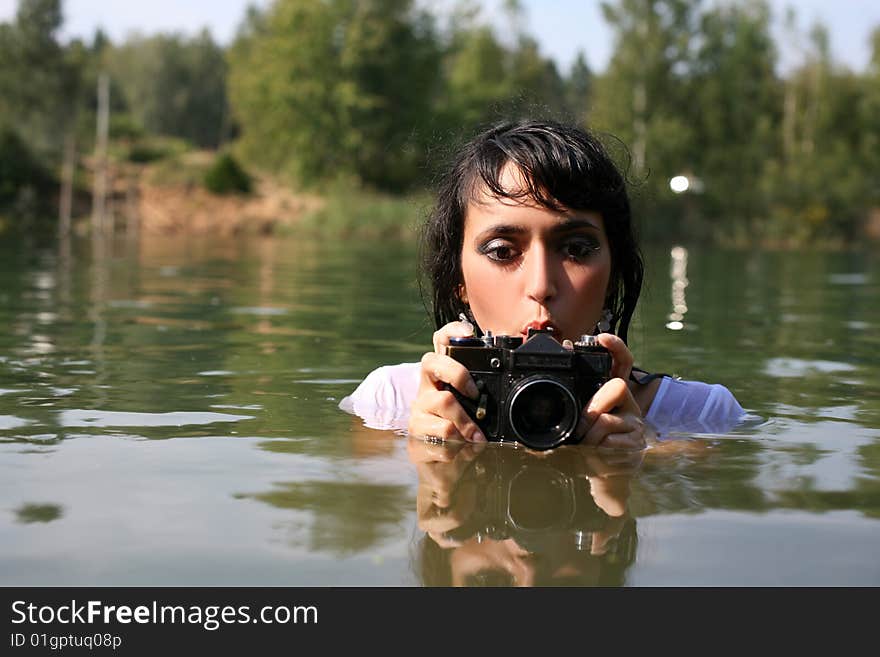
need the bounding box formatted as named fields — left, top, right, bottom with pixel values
left=508, top=376, right=579, bottom=449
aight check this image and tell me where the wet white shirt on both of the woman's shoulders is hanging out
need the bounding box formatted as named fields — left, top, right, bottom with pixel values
left=339, top=363, right=746, bottom=437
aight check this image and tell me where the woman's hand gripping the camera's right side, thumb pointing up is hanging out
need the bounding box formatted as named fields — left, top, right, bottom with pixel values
left=577, top=333, right=648, bottom=450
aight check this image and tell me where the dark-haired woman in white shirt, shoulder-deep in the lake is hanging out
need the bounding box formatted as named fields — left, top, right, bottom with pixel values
left=341, top=121, right=744, bottom=450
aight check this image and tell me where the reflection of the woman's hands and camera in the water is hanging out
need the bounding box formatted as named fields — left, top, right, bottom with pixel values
left=408, top=438, right=642, bottom=586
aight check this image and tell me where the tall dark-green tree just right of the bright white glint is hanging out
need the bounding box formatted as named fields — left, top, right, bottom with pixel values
left=688, top=0, right=780, bottom=239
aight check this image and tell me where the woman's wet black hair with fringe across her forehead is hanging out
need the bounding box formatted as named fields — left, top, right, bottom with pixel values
left=422, top=121, right=644, bottom=341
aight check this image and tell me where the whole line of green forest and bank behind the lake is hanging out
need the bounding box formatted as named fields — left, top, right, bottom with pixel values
left=0, top=0, right=880, bottom=247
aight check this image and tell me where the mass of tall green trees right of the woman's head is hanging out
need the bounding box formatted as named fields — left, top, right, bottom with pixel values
left=589, top=0, right=880, bottom=245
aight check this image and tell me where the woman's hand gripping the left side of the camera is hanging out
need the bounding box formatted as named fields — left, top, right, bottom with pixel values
left=409, top=322, right=486, bottom=443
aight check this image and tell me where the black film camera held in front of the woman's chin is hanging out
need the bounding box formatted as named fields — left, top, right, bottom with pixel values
left=446, top=329, right=611, bottom=450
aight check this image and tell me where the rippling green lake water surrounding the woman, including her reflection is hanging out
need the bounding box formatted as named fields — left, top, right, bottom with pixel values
left=0, top=231, right=880, bottom=586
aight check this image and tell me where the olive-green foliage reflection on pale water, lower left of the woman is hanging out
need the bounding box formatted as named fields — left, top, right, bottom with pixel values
left=240, top=481, right=409, bottom=556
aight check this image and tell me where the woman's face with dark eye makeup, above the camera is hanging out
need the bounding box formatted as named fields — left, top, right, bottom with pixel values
left=461, top=165, right=611, bottom=341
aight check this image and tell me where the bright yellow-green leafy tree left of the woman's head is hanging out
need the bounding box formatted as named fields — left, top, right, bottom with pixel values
left=229, top=0, right=439, bottom=189
